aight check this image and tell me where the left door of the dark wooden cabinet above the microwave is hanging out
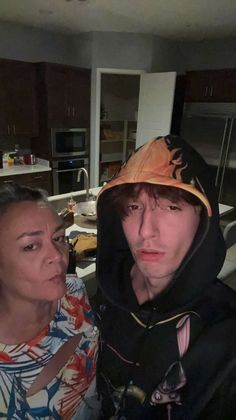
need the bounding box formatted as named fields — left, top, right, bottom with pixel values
left=43, top=64, right=70, bottom=128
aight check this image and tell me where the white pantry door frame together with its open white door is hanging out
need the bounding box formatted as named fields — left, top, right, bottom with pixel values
left=90, top=68, right=176, bottom=187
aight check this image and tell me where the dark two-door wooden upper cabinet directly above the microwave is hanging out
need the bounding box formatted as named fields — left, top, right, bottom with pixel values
left=36, top=63, right=91, bottom=127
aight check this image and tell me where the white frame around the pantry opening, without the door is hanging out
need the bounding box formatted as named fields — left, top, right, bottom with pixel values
left=90, top=67, right=146, bottom=187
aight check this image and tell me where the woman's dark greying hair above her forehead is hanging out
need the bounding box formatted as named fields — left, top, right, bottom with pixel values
left=0, top=182, right=49, bottom=215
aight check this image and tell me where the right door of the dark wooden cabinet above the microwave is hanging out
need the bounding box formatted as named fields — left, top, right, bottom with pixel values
left=67, top=68, right=91, bottom=127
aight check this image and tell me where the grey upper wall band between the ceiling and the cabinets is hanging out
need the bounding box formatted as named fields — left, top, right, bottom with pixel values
left=0, top=22, right=236, bottom=73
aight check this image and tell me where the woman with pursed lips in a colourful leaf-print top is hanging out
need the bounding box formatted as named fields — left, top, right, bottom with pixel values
left=0, top=185, right=97, bottom=419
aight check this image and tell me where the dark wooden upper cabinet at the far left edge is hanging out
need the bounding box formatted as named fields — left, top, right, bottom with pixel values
left=0, top=59, right=38, bottom=137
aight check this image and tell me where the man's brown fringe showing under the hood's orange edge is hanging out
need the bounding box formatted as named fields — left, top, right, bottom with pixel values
left=106, top=182, right=202, bottom=219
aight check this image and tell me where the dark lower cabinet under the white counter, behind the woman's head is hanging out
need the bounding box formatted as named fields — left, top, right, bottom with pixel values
left=0, top=171, right=52, bottom=195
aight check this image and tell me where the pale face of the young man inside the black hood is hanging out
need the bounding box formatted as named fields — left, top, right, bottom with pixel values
left=122, top=191, right=201, bottom=294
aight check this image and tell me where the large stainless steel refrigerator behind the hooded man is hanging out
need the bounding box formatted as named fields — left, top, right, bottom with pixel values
left=180, top=103, right=236, bottom=207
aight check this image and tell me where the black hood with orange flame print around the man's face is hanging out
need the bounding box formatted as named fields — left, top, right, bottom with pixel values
left=97, top=135, right=225, bottom=312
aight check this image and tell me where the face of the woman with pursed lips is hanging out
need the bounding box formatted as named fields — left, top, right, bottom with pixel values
left=0, top=201, right=68, bottom=301
